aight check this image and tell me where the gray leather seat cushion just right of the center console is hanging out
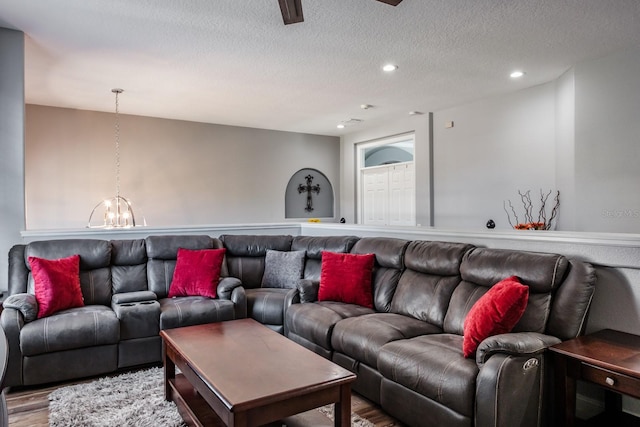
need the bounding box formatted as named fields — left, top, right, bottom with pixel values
left=158, top=296, right=235, bottom=329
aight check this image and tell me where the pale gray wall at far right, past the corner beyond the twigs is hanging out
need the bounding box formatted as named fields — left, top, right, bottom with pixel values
left=575, top=48, right=640, bottom=233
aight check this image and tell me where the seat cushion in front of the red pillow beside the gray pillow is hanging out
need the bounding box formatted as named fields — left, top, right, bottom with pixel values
left=286, top=301, right=374, bottom=351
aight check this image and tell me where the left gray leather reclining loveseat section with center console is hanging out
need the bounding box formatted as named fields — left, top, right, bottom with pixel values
left=0, top=235, right=246, bottom=386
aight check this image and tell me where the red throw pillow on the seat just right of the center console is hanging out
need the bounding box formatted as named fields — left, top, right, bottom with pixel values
left=169, top=248, right=225, bottom=298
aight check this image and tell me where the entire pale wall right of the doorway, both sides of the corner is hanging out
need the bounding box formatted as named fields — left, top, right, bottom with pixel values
left=433, top=48, right=640, bottom=233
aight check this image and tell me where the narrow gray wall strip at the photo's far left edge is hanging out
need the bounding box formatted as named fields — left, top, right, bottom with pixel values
left=0, top=28, right=25, bottom=291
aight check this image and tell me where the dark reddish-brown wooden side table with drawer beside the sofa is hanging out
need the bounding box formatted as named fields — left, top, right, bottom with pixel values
left=549, top=329, right=640, bottom=427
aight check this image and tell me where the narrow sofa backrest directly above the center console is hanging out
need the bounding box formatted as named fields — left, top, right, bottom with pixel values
left=111, top=239, right=148, bottom=294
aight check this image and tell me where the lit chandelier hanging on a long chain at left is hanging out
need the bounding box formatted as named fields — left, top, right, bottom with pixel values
left=87, top=89, right=136, bottom=228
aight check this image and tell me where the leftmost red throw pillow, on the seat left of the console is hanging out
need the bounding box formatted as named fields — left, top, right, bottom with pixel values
left=28, top=255, right=84, bottom=319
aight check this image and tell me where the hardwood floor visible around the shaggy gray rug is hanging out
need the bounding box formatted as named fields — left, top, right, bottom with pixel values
left=6, top=372, right=402, bottom=427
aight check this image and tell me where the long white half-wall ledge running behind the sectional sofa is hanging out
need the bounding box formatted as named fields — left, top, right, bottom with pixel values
left=21, top=222, right=640, bottom=269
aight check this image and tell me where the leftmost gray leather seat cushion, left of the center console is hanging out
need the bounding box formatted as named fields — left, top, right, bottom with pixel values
left=20, top=305, right=120, bottom=356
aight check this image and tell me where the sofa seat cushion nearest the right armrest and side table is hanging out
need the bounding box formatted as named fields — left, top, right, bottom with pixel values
left=378, top=334, right=479, bottom=417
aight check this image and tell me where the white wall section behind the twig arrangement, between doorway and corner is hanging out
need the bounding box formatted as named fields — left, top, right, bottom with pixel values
left=433, top=83, right=562, bottom=229
